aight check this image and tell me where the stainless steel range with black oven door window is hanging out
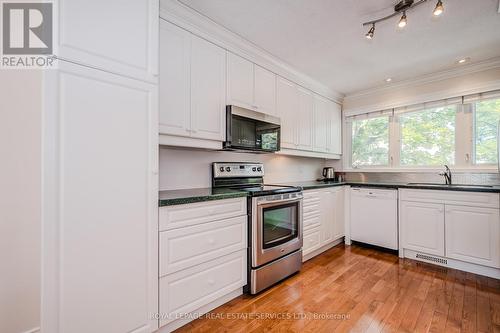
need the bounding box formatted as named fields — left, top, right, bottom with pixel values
left=212, top=162, right=302, bottom=294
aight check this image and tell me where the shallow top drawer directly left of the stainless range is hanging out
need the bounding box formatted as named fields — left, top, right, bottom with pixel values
left=159, top=198, right=247, bottom=231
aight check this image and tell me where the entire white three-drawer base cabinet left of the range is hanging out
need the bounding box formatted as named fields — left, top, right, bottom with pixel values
left=159, top=198, right=248, bottom=332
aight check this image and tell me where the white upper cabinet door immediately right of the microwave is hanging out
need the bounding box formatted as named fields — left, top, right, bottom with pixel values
left=277, top=77, right=299, bottom=149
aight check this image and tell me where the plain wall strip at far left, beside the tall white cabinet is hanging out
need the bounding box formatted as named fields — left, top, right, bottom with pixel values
left=0, top=70, right=42, bottom=333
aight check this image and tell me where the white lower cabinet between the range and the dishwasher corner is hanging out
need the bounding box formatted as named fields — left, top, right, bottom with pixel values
left=302, top=187, right=344, bottom=258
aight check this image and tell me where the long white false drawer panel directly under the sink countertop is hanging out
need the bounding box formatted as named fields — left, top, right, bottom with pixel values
left=400, top=189, right=500, bottom=208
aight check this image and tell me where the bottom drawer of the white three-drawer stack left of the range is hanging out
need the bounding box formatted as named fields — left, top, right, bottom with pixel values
left=159, top=250, right=247, bottom=326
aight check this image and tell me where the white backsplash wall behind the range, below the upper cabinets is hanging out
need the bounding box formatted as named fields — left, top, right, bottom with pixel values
left=160, top=148, right=325, bottom=190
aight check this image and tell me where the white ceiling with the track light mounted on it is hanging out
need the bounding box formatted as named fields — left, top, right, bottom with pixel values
left=181, top=0, right=500, bottom=94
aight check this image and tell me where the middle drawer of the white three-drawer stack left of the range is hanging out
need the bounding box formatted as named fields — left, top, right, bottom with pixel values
left=160, top=216, right=247, bottom=276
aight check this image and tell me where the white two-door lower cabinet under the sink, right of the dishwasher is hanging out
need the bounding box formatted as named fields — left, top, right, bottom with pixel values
left=400, top=189, right=500, bottom=276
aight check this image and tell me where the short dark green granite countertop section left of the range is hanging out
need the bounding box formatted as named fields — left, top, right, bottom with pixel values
left=158, top=187, right=247, bottom=207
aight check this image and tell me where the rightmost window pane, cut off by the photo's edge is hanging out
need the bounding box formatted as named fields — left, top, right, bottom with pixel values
left=473, top=99, right=500, bottom=165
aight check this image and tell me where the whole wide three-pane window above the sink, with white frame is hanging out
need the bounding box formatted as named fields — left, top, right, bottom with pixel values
left=344, top=90, right=500, bottom=171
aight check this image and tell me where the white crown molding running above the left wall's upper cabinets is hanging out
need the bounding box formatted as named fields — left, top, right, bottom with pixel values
left=160, top=0, right=344, bottom=104
